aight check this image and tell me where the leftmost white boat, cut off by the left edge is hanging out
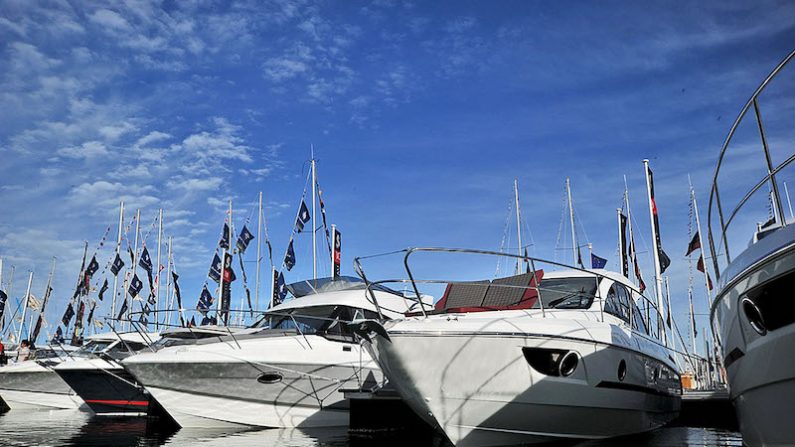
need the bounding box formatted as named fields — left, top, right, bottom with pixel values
left=0, top=346, right=83, bottom=410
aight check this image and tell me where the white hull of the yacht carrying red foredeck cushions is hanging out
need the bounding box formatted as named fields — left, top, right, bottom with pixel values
left=369, top=316, right=681, bottom=446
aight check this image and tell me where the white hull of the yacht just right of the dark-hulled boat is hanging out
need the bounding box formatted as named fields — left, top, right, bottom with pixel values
left=123, top=336, right=382, bottom=428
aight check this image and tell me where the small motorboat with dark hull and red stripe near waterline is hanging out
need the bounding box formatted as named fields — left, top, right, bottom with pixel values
left=52, top=332, right=159, bottom=416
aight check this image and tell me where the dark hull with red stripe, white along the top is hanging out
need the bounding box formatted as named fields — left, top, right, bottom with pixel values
left=55, top=359, right=150, bottom=416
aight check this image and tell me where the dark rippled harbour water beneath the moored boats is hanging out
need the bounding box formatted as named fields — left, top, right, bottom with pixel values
left=0, top=410, right=742, bottom=447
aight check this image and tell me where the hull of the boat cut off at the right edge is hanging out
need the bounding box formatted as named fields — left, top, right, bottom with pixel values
left=712, top=231, right=795, bottom=446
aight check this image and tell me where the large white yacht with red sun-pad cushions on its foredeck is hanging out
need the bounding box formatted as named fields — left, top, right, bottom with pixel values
left=356, top=248, right=681, bottom=446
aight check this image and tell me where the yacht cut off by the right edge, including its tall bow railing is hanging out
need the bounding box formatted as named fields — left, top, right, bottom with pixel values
left=708, top=51, right=795, bottom=446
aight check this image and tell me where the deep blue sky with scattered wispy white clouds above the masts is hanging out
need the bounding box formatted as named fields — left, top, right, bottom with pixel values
left=0, top=0, right=795, bottom=350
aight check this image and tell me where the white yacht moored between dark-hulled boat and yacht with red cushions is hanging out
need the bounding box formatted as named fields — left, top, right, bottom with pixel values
left=122, top=277, right=430, bottom=428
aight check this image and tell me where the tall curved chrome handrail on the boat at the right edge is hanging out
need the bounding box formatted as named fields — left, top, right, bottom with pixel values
left=707, top=50, right=795, bottom=280
